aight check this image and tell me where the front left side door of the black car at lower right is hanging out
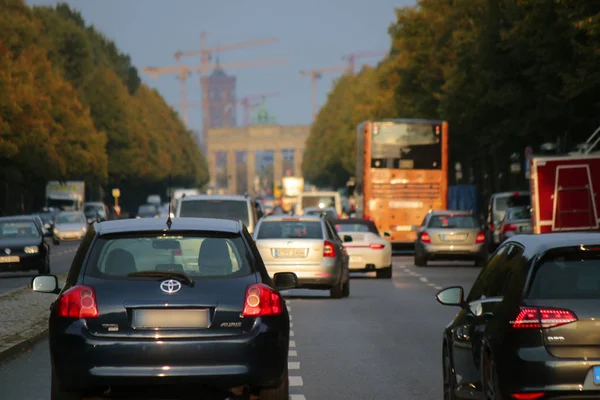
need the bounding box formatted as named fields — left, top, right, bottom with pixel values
left=449, top=244, right=510, bottom=390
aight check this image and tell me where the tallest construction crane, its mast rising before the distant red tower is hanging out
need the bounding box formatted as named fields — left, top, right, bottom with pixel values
left=174, top=32, right=279, bottom=135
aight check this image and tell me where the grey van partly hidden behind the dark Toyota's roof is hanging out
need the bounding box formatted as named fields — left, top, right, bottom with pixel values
left=175, top=194, right=257, bottom=234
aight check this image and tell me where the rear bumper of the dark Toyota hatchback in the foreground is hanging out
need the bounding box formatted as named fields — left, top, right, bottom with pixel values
left=50, top=315, right=289, bottom=392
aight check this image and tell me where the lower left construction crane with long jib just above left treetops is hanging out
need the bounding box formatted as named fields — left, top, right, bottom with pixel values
left=142, top=59, right=289, bottom=123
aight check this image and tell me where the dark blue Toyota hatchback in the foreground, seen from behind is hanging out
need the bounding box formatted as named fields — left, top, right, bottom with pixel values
left=32, top=218, right=297, bottom=400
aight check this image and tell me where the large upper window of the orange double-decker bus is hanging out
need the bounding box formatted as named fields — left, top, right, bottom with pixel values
left=371, top=122, right=442, bottom=169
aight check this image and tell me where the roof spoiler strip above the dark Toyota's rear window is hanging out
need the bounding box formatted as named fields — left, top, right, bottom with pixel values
left=94, top=218, right=242, bottom=235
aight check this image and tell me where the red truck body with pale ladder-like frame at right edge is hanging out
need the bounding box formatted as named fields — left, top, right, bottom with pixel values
left=529, top=153, right=600, bottom=234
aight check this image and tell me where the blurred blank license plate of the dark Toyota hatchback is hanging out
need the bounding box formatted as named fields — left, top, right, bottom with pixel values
left=131, top=309, right=209, bottom=329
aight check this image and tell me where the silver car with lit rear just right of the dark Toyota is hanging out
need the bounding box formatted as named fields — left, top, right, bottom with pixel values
left=254, top=215, right=352, bottom=298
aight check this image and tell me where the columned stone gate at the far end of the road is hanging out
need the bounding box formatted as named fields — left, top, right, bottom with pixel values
left=206, top=125, right=310, bottom=194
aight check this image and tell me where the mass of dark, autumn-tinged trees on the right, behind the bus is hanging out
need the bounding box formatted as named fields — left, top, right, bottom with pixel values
left=304, top=0, right=600, bottom=190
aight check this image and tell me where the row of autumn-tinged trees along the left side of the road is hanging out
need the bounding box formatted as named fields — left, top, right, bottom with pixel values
left=0, top=0, right=208, bottom=212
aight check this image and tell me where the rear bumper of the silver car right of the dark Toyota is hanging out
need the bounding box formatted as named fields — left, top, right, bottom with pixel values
left=265, top=260, right=342, bottom=289
